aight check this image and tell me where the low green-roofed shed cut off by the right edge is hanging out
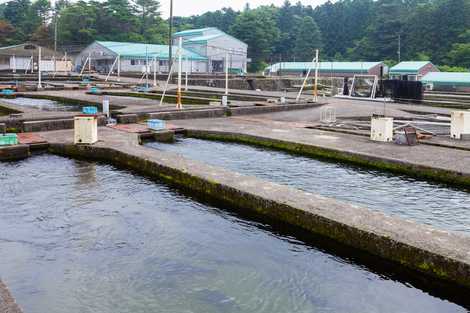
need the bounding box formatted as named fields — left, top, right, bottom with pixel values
left=421, top=72, right=470, bottom=92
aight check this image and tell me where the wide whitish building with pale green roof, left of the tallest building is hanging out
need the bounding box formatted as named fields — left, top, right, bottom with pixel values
left=75, top=41, right=208, bottom=73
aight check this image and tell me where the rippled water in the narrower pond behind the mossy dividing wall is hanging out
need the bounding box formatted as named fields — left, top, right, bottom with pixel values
left=147, top=138, right=470, bottom=233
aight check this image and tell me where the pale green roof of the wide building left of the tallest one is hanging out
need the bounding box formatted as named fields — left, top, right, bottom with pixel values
left=97, top=41, right=207, bottom=60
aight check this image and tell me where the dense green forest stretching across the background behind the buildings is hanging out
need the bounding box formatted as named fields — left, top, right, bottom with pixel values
left=0, top=0, right=470, bottom=70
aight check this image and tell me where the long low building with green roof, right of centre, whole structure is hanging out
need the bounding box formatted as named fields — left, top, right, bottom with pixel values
left=264, top=62, right=388, bottom=77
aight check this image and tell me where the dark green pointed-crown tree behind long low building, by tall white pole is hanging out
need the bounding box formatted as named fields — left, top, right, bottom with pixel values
left=295, top=16, right=322, bottom=62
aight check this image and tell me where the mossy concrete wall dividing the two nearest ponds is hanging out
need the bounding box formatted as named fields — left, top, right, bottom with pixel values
left=49, top=137, right=470, bottom=287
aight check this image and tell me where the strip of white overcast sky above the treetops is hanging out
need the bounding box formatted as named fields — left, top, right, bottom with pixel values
left=160, top=0, right=326, bottom=17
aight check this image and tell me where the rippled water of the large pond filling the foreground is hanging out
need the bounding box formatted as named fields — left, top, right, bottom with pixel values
left=0, top=154, right=470, bottom=313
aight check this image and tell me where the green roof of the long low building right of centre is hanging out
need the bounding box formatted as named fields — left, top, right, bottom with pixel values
left=266, top=62, right=382, bottom=73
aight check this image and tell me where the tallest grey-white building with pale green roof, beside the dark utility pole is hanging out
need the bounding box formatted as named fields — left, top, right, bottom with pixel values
left=173, top=27, right=248, bottom=73
